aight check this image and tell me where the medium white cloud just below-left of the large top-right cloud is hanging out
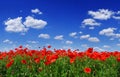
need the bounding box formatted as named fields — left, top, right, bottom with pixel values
left=82, top=18, right=101, bottom=27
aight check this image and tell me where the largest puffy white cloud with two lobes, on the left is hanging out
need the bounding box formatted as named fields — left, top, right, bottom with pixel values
left=4, top=16, right=47, bottom=33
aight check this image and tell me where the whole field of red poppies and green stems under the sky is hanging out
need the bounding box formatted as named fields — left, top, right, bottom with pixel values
left=0, top=46, right=120, bottom=77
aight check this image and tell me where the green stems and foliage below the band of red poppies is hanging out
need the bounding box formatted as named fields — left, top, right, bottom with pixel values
left=0, top=56, right=120, bottom=77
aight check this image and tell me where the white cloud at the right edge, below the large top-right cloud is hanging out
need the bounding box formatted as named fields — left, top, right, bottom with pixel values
left=99, top=28, right=120, bottom=38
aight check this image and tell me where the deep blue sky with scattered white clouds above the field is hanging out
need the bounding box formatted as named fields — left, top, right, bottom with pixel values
left=0, top=0, right=120, bottom=51
